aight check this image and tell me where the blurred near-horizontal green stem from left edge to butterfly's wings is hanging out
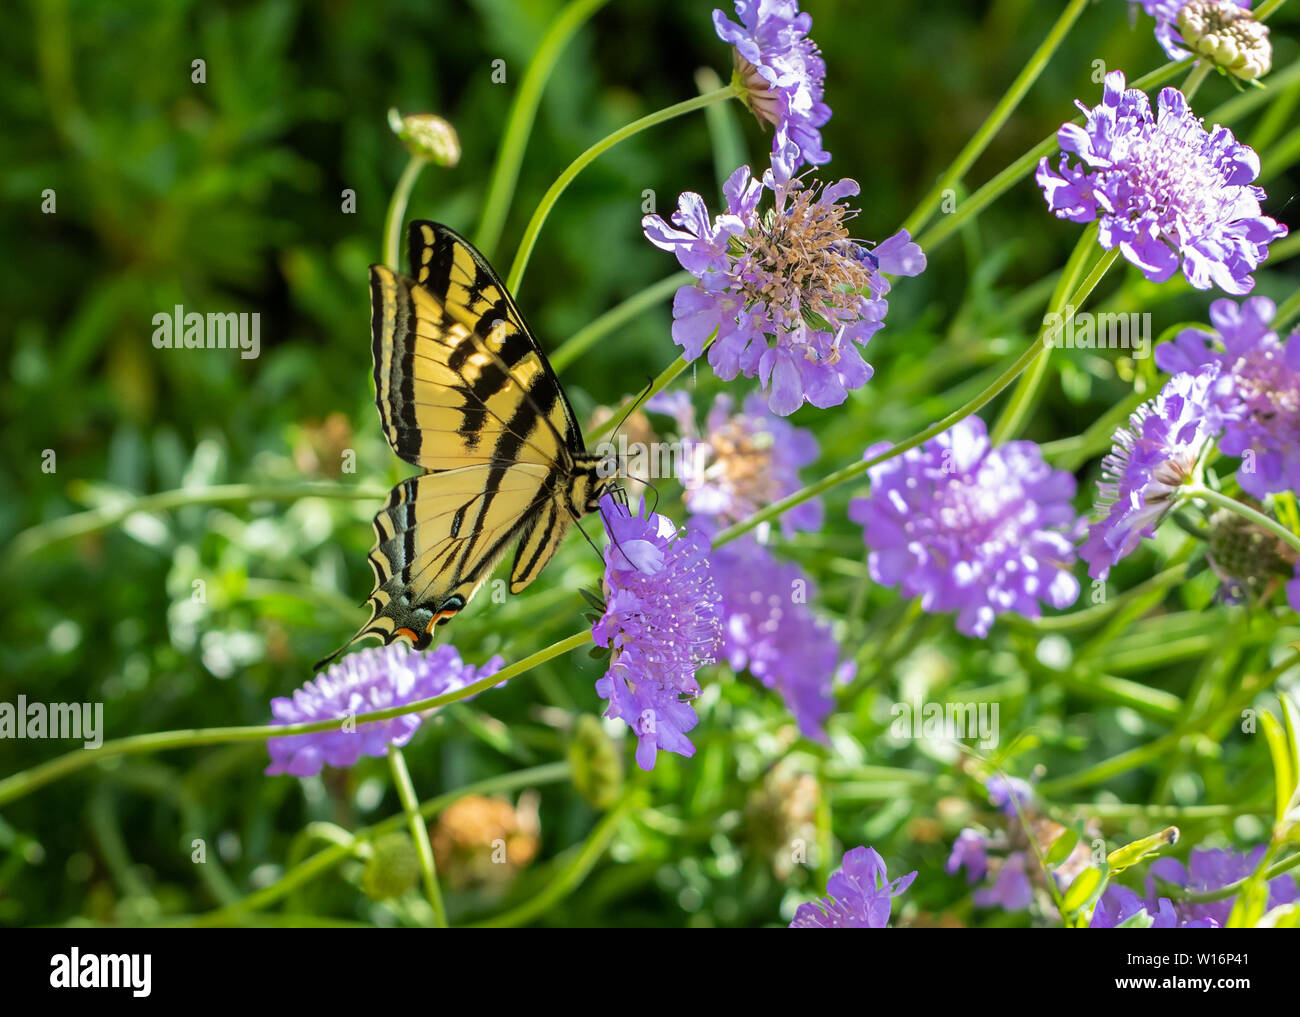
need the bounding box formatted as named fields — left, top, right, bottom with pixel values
left=8, top=484, right=389, bottom=561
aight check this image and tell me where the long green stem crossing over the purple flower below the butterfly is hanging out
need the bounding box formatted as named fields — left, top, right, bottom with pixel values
left=0, top=629, right=592, bottom=805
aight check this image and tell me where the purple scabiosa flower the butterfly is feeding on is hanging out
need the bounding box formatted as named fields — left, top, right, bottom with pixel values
left=592, top=494, right=722, bottom=770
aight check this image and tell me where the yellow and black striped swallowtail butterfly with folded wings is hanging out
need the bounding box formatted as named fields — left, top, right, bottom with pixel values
left=317, top=220, right=616, bottom=667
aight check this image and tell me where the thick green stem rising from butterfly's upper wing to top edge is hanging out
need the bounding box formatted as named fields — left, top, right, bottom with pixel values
left=475, top=0, right=608, bottom=256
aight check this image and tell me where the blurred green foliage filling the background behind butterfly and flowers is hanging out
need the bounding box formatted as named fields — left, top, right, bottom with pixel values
left=0, top=0, right=1300, bottom=926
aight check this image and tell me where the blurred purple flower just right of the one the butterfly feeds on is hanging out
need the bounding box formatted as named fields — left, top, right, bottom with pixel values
left=710, top=535, right=840, bottom=743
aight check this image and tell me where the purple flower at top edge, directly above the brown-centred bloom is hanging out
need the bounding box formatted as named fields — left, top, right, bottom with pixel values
left=714, top=0, right=831, bottom=165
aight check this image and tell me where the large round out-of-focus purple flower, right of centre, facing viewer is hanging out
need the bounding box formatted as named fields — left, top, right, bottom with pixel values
left=849, top=416, right=1079, bottom=639
